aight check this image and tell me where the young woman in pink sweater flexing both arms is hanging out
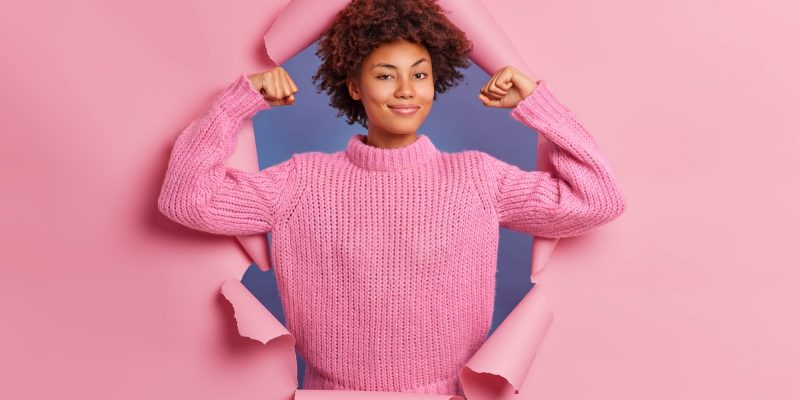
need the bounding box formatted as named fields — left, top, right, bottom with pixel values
left=159, top=0, right=625, bottom=394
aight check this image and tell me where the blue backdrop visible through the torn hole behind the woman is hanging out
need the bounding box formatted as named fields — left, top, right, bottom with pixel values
left=242, top=42, right=537, bottom=388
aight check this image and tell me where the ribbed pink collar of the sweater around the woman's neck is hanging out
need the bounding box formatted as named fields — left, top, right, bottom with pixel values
left=345, top=134, right=438, bottom=171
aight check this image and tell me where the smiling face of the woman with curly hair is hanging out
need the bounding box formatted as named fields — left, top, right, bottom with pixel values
left=348, top=39, right=434, bottom=137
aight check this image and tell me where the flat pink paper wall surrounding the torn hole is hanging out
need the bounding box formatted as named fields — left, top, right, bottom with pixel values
left=0, top=0, right=800, bottom=399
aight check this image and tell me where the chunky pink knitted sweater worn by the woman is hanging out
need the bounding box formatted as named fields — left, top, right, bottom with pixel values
left=158, top=73, right=625, bottom=394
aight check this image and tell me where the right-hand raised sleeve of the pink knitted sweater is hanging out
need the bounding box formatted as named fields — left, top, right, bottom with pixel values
left=482, top=80, right=626, bottom=238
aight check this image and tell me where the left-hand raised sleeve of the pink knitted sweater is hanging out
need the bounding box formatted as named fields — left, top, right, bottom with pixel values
left=158, top=73, right=295, bottom=235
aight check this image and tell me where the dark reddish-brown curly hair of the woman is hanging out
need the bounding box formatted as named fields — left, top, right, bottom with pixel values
left=313, top=0, right=472, bottom=128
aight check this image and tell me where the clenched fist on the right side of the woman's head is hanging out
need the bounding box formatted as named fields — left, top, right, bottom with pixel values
left=478, top=66, right=538, bottom=108
